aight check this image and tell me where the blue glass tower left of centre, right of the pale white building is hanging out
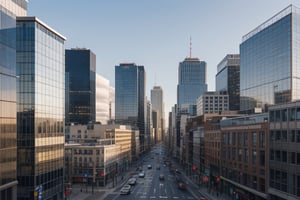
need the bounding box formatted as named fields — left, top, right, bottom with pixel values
left=115, top=63, right=146, bottom=152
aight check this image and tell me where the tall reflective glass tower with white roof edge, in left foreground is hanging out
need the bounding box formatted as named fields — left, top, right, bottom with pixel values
left=16, top=17, right=65, bottom=200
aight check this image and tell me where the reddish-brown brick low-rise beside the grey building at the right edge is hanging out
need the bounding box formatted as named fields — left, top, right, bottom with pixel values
left=219, top=113, right=269, bottom=200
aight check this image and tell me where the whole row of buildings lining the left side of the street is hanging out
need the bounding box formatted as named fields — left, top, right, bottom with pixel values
left=0, top=0, right=164, bottom=200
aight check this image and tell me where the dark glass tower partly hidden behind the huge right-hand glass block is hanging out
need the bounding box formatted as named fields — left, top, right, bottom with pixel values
left=216, top=54, right=240, bottom=110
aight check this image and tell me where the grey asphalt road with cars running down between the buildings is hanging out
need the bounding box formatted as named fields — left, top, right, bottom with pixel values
left=116, top=145, right=195, bottom=200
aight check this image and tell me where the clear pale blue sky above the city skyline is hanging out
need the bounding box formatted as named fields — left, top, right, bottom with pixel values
left=28, top=0, right=300, bottom=113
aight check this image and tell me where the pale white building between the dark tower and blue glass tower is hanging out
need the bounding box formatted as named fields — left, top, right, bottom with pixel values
left=96, top=74, right=114, bottom=124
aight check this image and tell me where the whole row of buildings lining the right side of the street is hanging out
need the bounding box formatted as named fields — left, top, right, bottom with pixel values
left=165, top=5, right=300, bottom=200
